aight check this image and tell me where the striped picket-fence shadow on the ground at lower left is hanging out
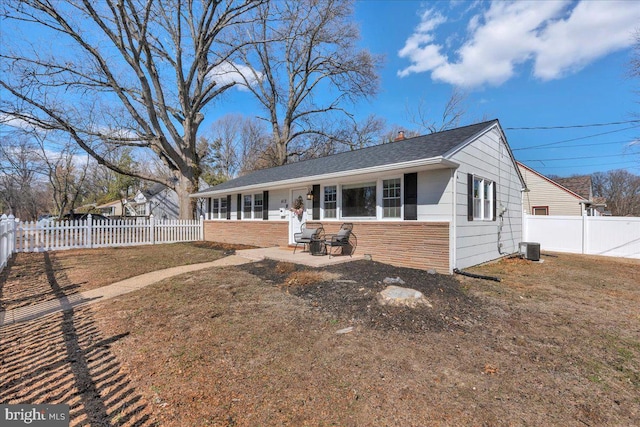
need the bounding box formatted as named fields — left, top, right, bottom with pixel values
left=0, top=254, right=155, bottom=426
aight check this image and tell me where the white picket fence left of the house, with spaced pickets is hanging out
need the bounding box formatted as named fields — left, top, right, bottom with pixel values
left=0, top=215, right=204, bottom=271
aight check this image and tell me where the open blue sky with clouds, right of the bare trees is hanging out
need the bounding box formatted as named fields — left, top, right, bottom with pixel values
left=355, top=0, right=640, bottom=176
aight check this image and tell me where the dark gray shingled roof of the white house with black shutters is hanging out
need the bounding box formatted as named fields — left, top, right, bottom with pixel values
left=192, top=120, right=498, bottom=197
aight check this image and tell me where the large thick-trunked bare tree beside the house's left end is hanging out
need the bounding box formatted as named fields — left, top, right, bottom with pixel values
left=0, top=0, right=265, bottom=218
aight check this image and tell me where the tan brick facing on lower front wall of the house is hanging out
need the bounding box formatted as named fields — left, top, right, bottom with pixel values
left=204, top=220, right=450, bottom=274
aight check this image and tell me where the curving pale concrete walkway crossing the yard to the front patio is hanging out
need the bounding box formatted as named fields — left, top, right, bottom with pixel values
left=0, top=248, right=362, bottom=327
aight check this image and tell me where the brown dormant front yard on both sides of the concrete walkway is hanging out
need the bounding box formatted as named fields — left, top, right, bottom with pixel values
left=0, top=244, right=640, bottom=426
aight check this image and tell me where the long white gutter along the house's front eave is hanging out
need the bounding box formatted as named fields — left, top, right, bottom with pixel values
left=189, top=156, right=460, bottom=198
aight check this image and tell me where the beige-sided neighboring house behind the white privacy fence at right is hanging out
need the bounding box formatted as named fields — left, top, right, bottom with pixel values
left=517, top=162, right=605, bottom=216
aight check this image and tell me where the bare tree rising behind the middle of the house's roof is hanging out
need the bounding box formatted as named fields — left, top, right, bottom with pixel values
left=225, top=0, right=380, bottom=165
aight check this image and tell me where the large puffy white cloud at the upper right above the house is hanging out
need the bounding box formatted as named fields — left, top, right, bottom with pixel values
left=398, top=0, right=640, bottom=87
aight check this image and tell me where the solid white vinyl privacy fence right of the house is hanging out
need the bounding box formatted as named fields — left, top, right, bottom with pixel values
left=523, top=214, right=640, bottom=258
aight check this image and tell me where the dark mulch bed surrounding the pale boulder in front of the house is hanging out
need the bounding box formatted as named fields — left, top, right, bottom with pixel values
left=243, top=260, right=485, bottom=333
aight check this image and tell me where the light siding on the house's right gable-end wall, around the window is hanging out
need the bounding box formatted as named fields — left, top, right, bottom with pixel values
left=451, top=128, right=522, bottom=268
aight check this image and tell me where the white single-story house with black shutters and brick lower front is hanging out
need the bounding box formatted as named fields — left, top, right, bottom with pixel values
left=191, top=120, right=525, bottom=273
